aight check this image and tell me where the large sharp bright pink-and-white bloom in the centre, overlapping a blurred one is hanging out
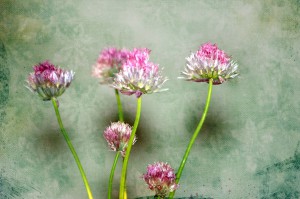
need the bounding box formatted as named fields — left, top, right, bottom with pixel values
left=112, top=48, right=167, bottom=97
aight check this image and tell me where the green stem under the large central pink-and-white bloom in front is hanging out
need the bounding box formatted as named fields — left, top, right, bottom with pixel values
left=119, top=97, right=142, bottom=199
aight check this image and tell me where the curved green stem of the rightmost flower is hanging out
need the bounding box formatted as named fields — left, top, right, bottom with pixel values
left=169, top=79, right=213, bottom=199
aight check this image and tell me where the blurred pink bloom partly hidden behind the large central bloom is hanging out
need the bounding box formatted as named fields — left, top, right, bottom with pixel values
left=92, top=48, right=129, bottom=84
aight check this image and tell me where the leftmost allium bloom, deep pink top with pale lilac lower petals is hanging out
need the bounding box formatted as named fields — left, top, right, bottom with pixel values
left=27, top=61, right=75, bottom=100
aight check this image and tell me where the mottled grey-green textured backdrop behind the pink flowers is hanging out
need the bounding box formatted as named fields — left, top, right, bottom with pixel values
left=0, top=0, right=300, bottom=199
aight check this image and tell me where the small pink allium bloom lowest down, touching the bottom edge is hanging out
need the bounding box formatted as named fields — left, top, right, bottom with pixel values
left=143, top=162, right=179, bottom=198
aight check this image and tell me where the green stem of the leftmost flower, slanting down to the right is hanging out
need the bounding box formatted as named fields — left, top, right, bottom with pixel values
left=51, top=98, right=93, bottom=199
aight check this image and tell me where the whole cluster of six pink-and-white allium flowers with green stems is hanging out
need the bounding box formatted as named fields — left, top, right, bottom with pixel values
left=27, top=43, right=238, bottom=199
